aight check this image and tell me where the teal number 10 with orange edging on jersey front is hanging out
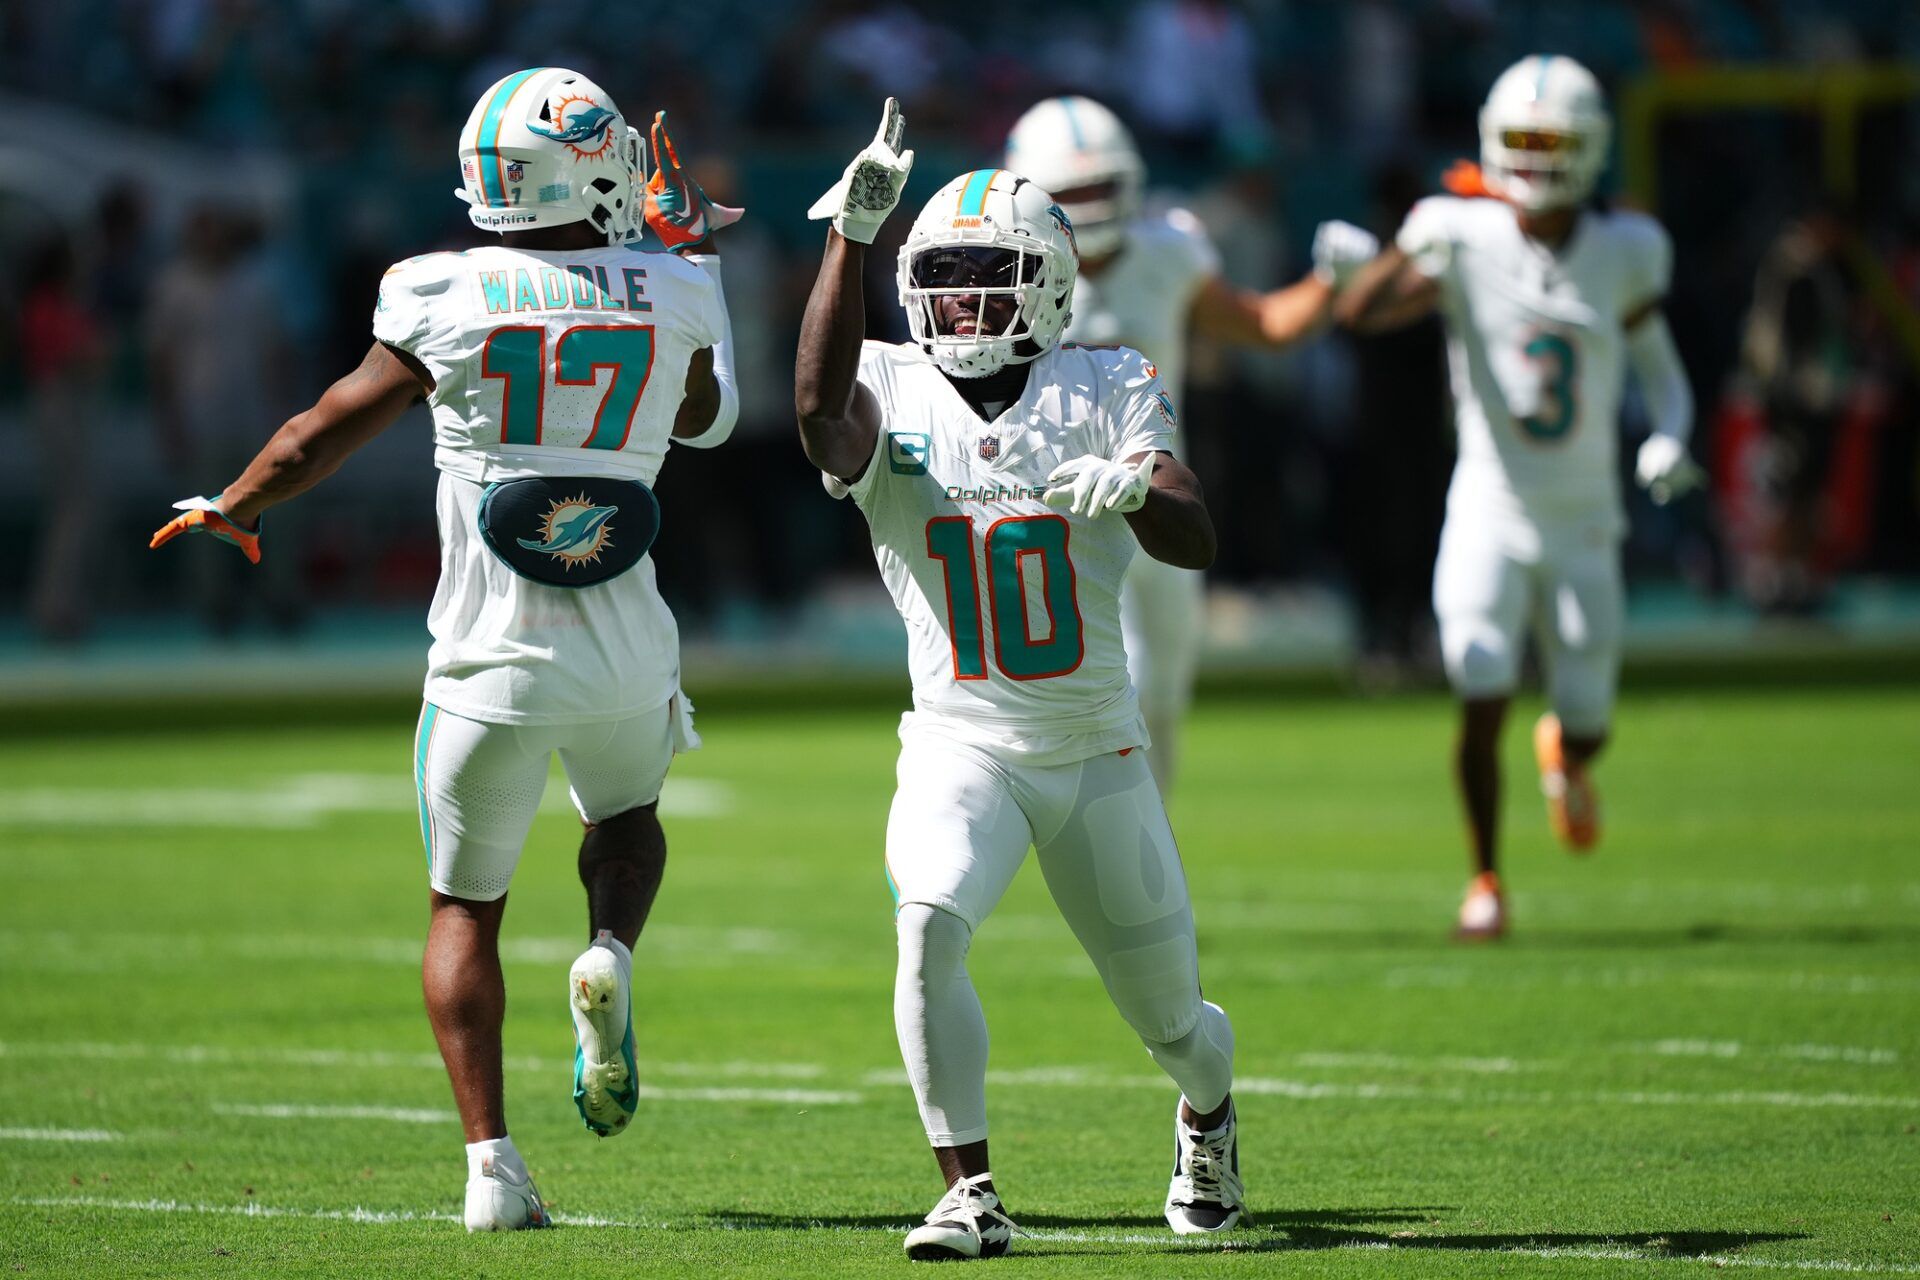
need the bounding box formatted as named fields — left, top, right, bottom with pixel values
left=927, top=516, right=1087, bottom=679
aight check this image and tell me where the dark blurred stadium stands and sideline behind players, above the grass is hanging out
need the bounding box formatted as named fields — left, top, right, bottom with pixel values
left=11, top=0, right=1920, bottom=708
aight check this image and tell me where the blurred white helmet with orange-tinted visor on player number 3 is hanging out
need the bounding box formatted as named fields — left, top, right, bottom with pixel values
left=1480, top=54, right=1613, bottom=213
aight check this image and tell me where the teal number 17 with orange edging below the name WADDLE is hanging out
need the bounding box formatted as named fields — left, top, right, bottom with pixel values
left=480, top=324, right=653, bottom=449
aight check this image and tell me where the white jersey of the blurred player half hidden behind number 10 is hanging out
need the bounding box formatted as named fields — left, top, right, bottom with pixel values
left=1066, top=209, right=1219, bottom=457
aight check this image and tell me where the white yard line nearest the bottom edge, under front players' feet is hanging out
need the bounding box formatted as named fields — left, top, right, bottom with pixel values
left=15, top=1196, right=1920, bottom=1276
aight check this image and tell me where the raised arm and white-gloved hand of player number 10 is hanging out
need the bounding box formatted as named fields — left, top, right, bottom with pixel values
left=793, top=98, right=914, bottom=480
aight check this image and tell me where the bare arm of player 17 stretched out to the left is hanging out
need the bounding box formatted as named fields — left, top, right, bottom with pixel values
left=219, top=342, right=434, bottom=526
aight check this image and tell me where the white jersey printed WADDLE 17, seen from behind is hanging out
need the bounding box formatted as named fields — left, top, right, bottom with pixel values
left=372, top=246, right=728, bottom=723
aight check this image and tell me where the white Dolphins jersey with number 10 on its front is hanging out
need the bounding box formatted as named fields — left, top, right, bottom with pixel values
left=852, top=342, right=1175, bottom=764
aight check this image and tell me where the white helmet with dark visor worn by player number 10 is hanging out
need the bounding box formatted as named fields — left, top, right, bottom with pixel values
left=899, top=169, right=1079, bottom=378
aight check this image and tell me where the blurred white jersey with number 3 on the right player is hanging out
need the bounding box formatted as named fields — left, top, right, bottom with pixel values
left=1396, top=196, right=1672, bottom=524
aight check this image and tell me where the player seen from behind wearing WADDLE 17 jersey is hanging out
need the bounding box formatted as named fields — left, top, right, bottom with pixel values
left=154, top=67, right=739, bottom=1230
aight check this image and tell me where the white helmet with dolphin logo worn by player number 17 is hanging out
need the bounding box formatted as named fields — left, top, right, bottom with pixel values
left=453, top=67, right=645, bottom=244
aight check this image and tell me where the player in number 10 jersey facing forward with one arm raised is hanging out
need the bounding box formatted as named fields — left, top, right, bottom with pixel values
left=795, top=98, right=1242, bottom=1259
